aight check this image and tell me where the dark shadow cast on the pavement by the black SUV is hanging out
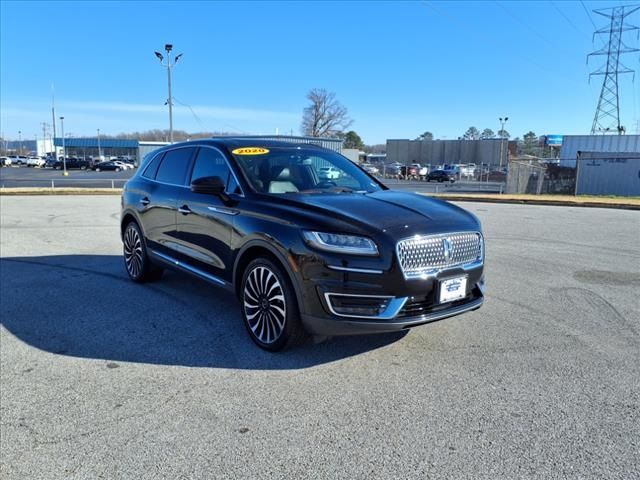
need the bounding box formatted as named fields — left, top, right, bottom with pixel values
left=0, top=255, right=407, bottom=370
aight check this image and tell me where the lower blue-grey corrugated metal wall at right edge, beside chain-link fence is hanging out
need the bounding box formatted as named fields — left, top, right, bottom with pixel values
left=576, top=152, right=640, bottom=196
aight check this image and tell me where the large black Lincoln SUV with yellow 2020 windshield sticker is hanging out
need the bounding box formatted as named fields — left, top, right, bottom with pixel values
left=121, top=137, right=484, bottom=350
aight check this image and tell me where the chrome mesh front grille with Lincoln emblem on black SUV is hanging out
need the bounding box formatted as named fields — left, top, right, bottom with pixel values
left=396, top=232, right=483, bottom=278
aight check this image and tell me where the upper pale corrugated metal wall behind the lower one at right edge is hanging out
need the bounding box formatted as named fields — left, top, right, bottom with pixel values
left=560, top=135, right=640, bottom=167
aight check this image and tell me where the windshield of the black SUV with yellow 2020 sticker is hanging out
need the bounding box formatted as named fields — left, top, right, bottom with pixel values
left=232, top=147, right=384, bottom=194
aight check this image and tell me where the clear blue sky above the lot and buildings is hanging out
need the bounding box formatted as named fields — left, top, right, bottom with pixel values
left=0, top=0, right=640, bottom=144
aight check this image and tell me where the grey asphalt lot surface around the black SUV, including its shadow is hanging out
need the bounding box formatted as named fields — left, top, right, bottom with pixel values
left=0, top=196, right=640, bottom=479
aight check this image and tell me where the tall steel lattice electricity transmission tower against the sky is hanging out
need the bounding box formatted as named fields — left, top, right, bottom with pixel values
left=587, top=5, right=640, bottom=135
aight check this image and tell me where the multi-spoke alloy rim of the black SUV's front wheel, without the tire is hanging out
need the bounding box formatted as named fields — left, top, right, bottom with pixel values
left=243, top=266, right=287, bottom=344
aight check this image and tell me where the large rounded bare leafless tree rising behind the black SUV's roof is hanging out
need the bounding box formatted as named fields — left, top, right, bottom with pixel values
left=301, top=88, right=353, bottom=137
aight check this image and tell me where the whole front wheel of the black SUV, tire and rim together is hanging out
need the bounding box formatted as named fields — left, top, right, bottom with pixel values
left=240, top=257, right=307, bottom=352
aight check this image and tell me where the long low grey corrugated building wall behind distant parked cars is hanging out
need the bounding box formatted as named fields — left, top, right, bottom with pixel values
left=387, top=139, right=508, bottom=165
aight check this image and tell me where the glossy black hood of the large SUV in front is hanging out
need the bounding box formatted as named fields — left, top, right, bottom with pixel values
left=270, top=190, right=480, bottom=235
